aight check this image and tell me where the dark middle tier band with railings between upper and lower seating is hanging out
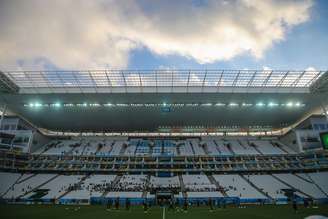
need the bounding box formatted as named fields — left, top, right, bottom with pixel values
left=0, top=151, right=328, bottom=173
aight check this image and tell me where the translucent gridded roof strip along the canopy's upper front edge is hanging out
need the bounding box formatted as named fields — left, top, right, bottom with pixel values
left=4, top=70, right=325, bottom=93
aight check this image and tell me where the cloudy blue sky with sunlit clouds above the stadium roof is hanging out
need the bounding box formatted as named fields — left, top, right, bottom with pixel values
left=0, top=0, right=328, bottom=70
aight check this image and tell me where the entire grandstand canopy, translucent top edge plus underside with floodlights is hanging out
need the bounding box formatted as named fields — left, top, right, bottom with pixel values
left=1, top=70, right=327, bottom=132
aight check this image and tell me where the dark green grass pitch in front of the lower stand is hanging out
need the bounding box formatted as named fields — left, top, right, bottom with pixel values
left=0, top=205, right=328, bottom=219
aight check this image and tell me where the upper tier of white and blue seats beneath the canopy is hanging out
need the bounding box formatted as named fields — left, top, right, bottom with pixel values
left=34, top=137, right=296, bottom=156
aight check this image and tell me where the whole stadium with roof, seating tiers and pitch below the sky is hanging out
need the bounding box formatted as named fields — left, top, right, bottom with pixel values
left=0, top=69, right=328, bottom=218
